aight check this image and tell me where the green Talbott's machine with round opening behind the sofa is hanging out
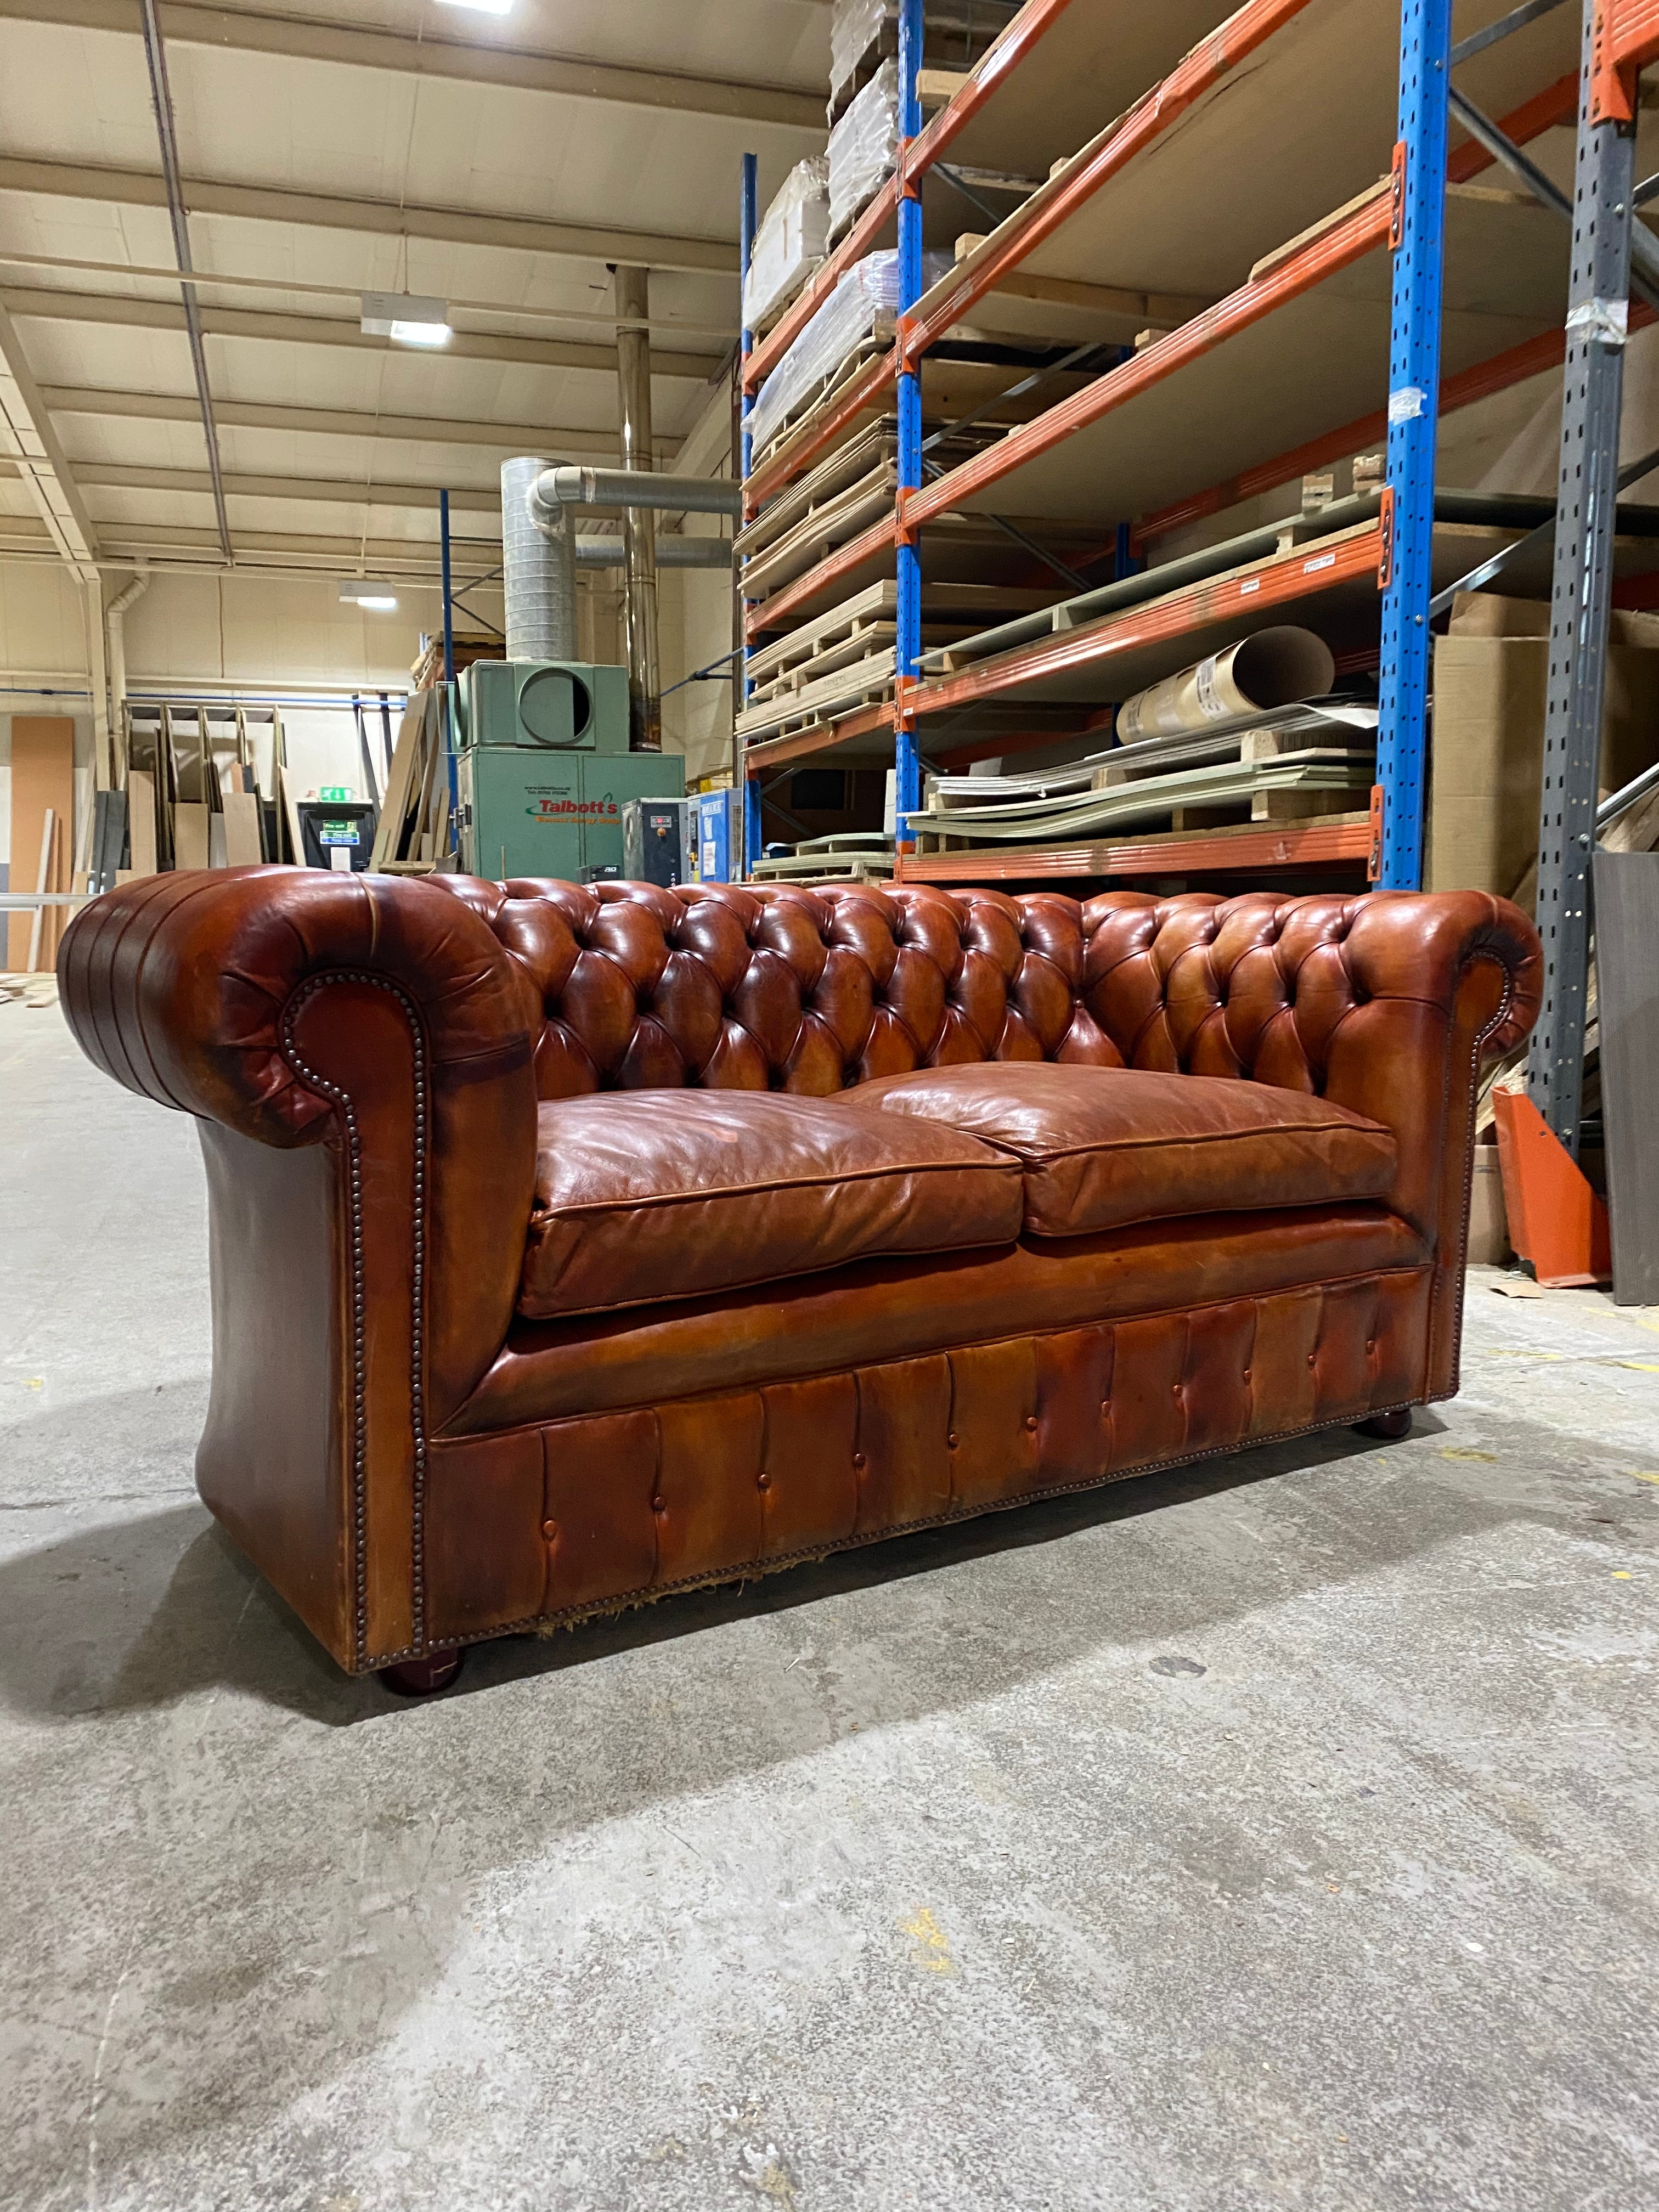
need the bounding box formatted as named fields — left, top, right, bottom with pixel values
left=456, top=662, right=686, bottom=883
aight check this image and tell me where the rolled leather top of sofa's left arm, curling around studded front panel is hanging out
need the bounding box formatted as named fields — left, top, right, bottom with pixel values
left=58, top=867, right=533, bottom=1146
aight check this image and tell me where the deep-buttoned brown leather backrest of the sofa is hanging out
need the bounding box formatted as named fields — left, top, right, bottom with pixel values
left=433, top=876, right=1442, bottom=1099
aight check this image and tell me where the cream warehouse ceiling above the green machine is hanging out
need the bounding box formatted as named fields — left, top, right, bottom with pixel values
left=0, top=0, right=830, bottom=571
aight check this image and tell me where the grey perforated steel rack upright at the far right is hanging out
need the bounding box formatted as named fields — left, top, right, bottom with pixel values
left=1526, top=0, right=1635, bottom=1159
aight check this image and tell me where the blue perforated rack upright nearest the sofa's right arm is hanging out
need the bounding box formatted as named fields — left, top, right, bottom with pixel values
left=1376, top=0, right=1451, bottom=891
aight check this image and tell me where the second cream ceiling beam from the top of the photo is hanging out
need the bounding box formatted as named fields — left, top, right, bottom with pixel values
left=0, top=155, right=737, bottom=283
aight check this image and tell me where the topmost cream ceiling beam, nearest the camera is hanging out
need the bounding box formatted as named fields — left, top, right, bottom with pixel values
left=0, top=0, right=825, bottom=135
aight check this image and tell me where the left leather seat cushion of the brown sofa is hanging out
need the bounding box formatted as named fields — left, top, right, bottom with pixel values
left=517, top=1091, right=1022, bottom=1321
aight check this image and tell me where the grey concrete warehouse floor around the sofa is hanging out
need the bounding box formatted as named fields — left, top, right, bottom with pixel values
left=0, top=1005, right=1659, bottom=2212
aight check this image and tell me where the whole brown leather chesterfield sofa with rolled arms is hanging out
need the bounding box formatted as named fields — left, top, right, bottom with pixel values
left=58, top=870, right=1539, bottom=1688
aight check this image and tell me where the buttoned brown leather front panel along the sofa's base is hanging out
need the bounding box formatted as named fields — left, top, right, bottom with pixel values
left=425, top=1265, right=1431, bottom=1644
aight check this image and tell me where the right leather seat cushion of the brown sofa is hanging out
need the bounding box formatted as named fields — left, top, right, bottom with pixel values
left=843, top=1062, right=1398, bottom=1237
